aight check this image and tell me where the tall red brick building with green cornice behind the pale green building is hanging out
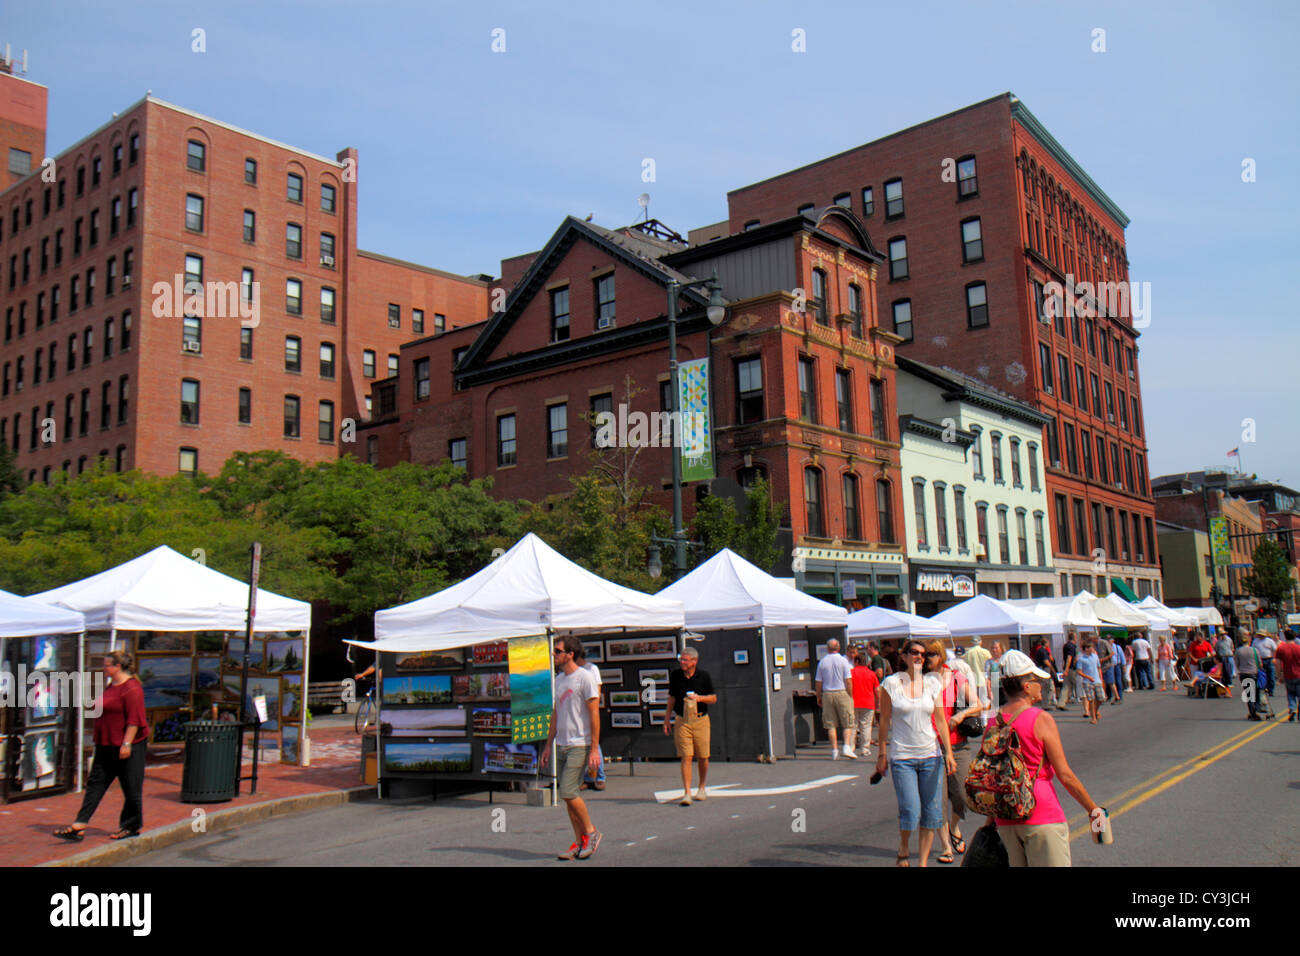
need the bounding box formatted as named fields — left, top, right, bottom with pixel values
left=728, top=94, right=1160, bottom=596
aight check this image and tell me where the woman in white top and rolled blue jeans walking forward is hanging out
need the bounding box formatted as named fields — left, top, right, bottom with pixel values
left=876, top=640, right=957, bottom=866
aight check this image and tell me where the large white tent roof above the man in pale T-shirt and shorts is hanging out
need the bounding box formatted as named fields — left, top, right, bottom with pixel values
left=371, top=533, right=685, bottom=652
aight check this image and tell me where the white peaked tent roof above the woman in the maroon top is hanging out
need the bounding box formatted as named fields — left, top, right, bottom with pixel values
left=31, top=545, right=312, bottom=632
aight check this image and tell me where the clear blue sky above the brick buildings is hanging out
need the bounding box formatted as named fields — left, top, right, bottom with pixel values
left=10, top=0, right=1300, bottom=486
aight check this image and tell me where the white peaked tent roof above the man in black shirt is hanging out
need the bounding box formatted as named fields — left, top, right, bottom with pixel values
left=658, top=548, right=849, bottom=628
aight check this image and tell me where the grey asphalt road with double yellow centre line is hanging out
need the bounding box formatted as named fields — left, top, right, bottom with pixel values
left=129, top=691, right=1300, bottom=866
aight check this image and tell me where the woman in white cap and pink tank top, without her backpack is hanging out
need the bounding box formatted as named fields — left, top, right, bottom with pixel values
left=993, top=650, right=1106, bottom=866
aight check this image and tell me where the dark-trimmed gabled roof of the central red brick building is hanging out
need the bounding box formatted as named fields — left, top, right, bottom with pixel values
left=459, top=216, right=709, bottom=371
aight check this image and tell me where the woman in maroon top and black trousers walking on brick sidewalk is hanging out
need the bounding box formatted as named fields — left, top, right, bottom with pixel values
left=55, top=650, right=150, bottom=840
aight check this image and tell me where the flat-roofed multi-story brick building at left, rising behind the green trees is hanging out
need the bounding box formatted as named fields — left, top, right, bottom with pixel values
left=0, top=96, right=489, bottom=481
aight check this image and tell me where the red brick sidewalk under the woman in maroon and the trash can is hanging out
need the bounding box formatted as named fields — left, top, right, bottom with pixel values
left=0, top=727, right=361, bottom=866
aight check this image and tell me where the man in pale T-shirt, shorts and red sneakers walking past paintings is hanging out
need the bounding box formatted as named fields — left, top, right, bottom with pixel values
left=538, top=635, right=601, bottom=860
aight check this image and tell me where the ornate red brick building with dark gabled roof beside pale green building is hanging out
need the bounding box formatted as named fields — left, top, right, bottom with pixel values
left=358, top=207, right=905, bottom=602
